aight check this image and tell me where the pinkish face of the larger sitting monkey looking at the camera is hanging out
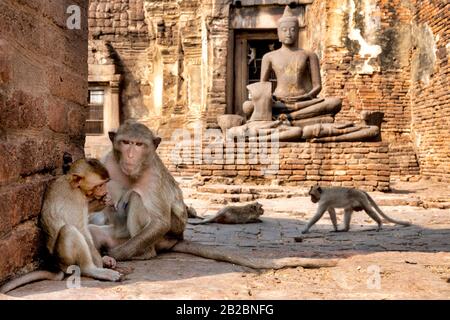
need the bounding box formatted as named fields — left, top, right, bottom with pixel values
left=118, top=139, right=149, bottom=177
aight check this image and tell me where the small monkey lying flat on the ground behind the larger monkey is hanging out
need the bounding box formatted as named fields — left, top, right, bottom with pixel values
left=189, top=202, right=264, bottom=224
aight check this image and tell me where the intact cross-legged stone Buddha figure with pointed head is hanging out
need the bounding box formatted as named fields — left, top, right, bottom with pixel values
left=261, top=6, right=342, bottom=126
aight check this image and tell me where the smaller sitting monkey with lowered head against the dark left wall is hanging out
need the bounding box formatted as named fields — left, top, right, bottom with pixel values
left=0, top=159, right=121, bottom=293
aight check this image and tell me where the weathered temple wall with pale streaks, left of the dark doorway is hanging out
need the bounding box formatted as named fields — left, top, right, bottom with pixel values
left=89, top=0, right=211, bottom=137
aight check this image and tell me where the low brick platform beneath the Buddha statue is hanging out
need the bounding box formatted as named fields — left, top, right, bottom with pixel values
left=158, top=142, right=391, bottom=191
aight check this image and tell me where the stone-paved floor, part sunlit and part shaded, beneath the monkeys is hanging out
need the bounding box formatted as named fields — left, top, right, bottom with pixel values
left=0, top=182, right=450, bottom=300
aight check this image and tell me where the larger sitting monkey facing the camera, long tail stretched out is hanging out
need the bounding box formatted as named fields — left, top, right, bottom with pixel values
left=93, top=121, right=336, bottom=269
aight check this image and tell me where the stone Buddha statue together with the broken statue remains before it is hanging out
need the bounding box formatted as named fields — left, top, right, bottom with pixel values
left=223, top=6, right=380, bottom=142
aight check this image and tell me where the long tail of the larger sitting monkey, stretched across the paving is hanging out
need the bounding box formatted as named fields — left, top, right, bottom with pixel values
left=171, top=240, right=337, bottom=269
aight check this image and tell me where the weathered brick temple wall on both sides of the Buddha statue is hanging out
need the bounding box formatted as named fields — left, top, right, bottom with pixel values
left=89, top=0, right=449, bottom=180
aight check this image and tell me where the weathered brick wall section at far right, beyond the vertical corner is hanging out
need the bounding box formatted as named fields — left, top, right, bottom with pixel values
left=411, top=0, right=450, bottom=182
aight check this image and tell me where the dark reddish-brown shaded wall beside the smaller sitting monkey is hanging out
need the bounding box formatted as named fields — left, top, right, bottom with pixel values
left=0, top=0, right=88, bottom=282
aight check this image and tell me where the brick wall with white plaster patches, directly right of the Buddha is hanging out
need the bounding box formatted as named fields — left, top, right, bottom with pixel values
left=308, top=0, right=419, bottom=179
